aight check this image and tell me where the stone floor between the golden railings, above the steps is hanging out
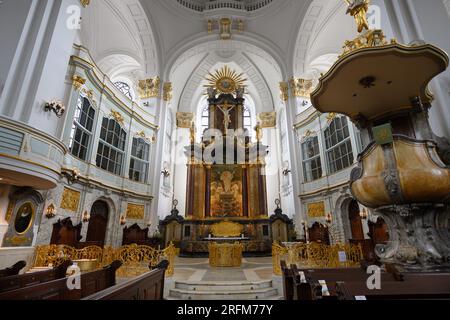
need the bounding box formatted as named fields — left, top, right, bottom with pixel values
left=173, top=257, right=272, bottom=282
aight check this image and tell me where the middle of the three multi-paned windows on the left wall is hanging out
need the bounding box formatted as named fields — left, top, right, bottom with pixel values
left=96, top=118, right=127, bottom=175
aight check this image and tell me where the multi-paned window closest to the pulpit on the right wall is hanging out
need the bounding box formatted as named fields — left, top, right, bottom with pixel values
left=325, top=117, right=354, bottom=174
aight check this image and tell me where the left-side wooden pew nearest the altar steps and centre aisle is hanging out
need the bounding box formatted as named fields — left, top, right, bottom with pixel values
left=83, top=260, right=169, bottom=300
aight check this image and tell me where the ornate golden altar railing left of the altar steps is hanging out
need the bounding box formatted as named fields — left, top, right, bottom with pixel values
left=33, top=243, right=176, bottom=277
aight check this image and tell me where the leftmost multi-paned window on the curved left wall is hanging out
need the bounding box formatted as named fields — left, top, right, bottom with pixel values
left=69, top=96, right=95, bottom=161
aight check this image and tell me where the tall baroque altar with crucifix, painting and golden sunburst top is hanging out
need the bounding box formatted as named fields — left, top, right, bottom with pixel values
left=182, top=66, right=271, bottom=253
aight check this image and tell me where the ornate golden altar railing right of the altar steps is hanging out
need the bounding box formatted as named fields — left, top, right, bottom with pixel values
left=272, top=242, right=363, bottom=275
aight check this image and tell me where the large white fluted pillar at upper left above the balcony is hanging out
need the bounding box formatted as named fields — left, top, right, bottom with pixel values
left=0, top=0, right=81, bottom=136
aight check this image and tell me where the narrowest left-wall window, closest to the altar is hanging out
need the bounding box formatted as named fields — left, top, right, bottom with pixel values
left=129, top=138, right=150, bottom=183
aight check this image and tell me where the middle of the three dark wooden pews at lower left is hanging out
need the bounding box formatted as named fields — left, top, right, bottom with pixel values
left=0, top=261, right=122, bottom=300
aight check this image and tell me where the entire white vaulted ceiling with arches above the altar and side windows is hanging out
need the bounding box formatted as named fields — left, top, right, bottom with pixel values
left=80, top=0, right=364, bottom=112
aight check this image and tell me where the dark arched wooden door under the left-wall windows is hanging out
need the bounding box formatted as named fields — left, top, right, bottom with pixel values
left=86, top=201, right=109, bottom=246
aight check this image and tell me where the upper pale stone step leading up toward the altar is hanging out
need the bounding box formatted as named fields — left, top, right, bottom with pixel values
left=175, top=280, right=272, bottom=291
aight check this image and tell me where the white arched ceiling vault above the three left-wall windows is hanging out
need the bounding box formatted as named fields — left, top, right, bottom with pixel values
left=80, top=0, right=160, bottom=77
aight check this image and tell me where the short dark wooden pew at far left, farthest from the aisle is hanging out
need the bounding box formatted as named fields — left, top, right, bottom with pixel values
left=0, top=261, right=72, bottom=293
